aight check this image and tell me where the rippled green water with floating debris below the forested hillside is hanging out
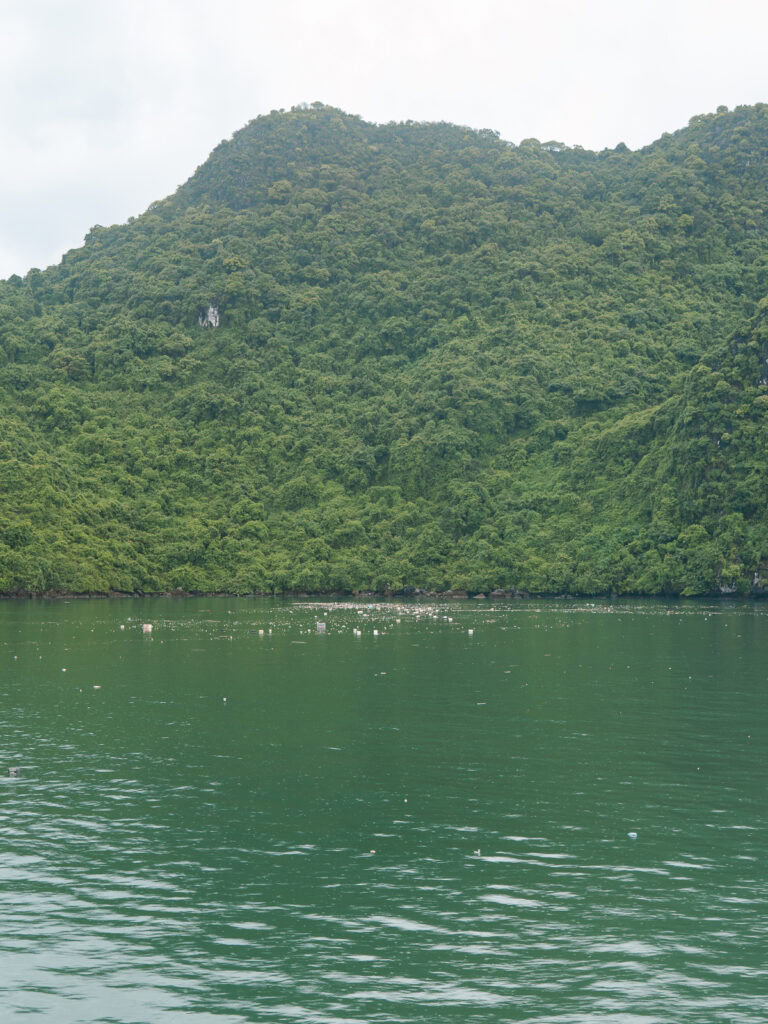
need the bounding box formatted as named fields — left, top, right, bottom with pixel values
left=0, top=599, right=768, bottom=1024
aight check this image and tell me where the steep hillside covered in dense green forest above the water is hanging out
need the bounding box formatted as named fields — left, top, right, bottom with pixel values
left=0, top=104, right=768, bottom=595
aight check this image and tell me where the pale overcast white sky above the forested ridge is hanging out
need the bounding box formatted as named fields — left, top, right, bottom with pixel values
left=0, top=0, right=768, bottom=278
